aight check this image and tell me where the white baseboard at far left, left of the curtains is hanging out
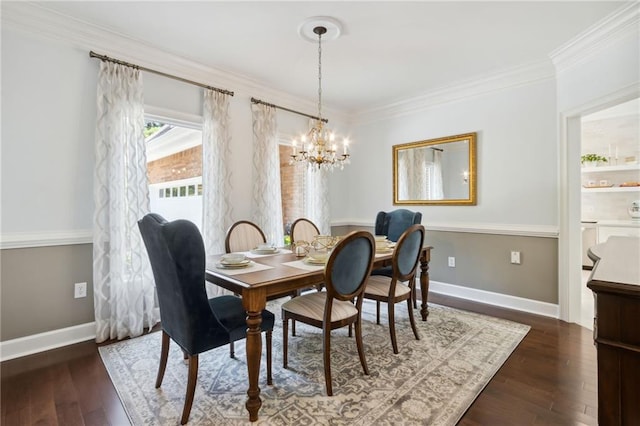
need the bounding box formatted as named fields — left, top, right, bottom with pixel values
left=0, top=322, right=96, bottom=361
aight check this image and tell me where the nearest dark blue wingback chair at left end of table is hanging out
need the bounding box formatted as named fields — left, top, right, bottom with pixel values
left=138, top=213, right=274, bottom=424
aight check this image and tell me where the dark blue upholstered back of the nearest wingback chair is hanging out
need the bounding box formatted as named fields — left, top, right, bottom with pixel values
left=138, top=213, right=226, bottom=354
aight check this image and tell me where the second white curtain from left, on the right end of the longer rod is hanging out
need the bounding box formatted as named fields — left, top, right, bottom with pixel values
left=202, top=89, right=232, bottom=297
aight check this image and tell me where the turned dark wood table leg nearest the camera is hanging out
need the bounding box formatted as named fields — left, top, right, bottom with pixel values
left=242, top=291, right=267, bottom=422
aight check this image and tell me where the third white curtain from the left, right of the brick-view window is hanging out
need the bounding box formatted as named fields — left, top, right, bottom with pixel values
left=251, top=104, right=284, bottom=245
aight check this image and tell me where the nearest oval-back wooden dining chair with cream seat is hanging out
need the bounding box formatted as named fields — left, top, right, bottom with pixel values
left=282, top=231, right=375, bottom=396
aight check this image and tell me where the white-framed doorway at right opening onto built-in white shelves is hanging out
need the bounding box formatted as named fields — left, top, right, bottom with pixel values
left=559, top=91, right=640, bottom=328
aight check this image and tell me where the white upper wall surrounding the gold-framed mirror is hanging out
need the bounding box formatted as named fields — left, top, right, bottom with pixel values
left=332, top=79, right=558, bottom=226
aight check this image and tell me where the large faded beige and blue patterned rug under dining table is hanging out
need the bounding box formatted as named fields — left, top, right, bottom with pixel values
left=99, top=301, right=529, bottom=426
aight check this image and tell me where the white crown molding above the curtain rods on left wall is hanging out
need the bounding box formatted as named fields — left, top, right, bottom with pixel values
left=2, top=2, right=350, bottom=122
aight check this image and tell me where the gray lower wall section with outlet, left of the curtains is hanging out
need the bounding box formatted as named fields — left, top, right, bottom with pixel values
left=0, top=244, right=94, bottom=341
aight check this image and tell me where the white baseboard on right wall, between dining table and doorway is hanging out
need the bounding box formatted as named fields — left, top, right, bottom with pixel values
left=429, top=281, right=560, bottom=318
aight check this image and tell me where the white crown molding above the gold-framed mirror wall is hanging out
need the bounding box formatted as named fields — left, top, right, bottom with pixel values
left=353, top=60, right=555, bottom=124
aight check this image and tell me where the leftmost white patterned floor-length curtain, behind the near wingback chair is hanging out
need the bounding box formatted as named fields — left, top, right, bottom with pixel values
left=93, top=61, right=160, bottom=342
